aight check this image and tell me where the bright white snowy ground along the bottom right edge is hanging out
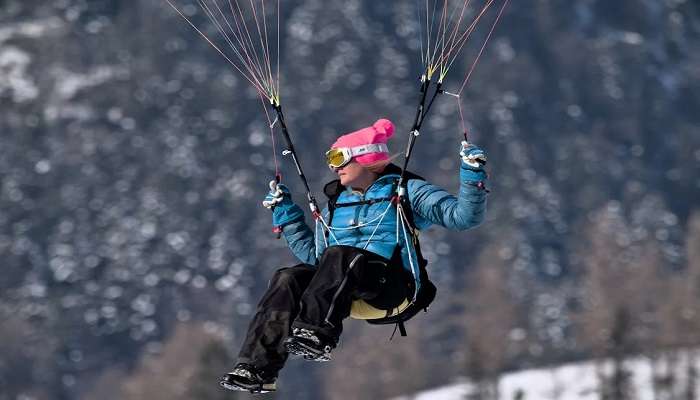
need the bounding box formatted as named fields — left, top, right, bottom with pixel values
left=394, top=358, right=684, bottom=400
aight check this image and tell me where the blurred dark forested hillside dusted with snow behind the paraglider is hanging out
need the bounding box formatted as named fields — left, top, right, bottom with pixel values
left=0, top=0, right=700, bottom=400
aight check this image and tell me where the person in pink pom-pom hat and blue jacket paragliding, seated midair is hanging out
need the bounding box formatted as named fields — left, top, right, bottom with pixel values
left=221, top=119, right=487, bottom=393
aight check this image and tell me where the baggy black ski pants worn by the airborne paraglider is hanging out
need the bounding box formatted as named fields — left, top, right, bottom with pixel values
left=238, top=246, right=413, bottom=376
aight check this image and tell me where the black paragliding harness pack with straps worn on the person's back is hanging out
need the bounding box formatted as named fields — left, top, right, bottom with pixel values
left=323, top=164, right=437, bottom=337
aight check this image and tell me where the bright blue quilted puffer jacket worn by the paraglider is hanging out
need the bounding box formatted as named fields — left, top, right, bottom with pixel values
left=282, top=164, right=486, bottom=286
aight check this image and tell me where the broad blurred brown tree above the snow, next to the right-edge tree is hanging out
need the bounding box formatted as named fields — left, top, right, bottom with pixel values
left=579, top=203, right=663, bottom=400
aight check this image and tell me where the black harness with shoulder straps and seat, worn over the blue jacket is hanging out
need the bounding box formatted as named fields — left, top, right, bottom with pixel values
left=323, top=164, right=437, bottom=337
